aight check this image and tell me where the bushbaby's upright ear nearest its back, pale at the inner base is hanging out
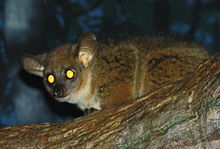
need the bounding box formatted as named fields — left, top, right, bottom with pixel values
left=76, top=32, right=97, bottom=67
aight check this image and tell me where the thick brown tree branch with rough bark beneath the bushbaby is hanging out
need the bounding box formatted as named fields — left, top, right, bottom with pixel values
left=0, top=55, right=220, bottom=149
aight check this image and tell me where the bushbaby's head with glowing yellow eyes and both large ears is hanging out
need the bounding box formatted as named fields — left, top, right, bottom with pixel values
left=20, top=33, right=97, bottom=103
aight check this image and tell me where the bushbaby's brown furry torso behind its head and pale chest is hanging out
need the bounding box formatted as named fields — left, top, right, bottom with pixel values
left=92, top=37, right=208, bottom=108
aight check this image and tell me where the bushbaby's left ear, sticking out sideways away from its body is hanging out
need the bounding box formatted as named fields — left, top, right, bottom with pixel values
left=20, top=53, right=46, bottom=77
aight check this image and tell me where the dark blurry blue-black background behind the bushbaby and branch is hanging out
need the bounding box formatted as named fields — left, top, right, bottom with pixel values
left=0, top=0, right=220, bottom=126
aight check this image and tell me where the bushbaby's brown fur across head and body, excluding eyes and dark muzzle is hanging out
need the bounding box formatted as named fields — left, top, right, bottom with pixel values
left=19, top=33, right=208, bottom=110
